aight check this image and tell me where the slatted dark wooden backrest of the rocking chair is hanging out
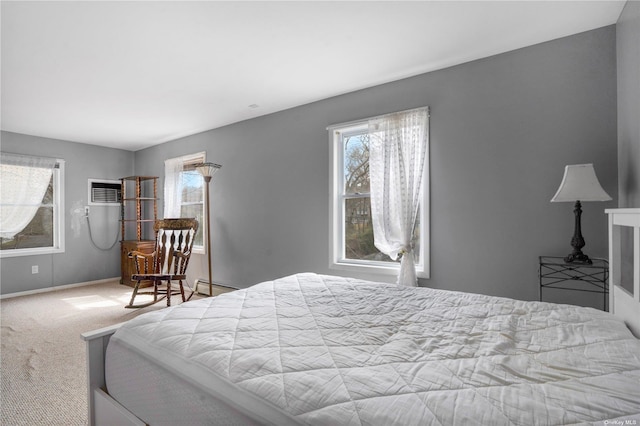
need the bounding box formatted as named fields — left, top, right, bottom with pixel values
left=153, top=218, right=198, bottom=275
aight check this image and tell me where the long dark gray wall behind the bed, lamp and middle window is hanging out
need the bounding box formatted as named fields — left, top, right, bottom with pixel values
left=135, top=26, right=618, bottom=306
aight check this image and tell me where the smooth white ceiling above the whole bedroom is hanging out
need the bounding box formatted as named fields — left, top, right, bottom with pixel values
left=1, top=1, right=625, bottom=151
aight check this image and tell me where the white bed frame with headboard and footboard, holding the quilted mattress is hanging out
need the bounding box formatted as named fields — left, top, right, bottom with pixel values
left=82, top=208, right=640, bottom=426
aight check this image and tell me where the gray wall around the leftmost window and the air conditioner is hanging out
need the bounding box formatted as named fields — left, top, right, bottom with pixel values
left=0, top=132, right=134, bottom=294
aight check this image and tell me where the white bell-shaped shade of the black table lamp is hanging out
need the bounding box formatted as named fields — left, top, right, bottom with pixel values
left=551, top=164, right=611, bottom=203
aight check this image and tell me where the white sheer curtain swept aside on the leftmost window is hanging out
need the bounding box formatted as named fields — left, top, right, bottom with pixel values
left=0, top=152, right=56, bottom=238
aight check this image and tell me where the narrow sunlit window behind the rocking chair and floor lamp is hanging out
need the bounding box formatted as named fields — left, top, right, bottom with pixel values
left=164, top=152, right=206, bottom=254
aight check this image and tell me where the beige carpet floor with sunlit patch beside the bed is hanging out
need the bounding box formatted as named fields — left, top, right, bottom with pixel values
left=0, top=280, right=197, bottom=426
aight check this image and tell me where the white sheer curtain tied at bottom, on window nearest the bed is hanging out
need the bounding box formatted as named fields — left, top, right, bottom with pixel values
left=369, top=108, right=429, bottom=286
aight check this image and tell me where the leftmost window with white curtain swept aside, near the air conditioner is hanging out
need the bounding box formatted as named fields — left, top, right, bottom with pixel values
left=0, top=153, right=64, bottom=258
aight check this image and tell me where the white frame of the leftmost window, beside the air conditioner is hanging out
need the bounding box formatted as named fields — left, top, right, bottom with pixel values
left=0, top=158, right=65, bottom=259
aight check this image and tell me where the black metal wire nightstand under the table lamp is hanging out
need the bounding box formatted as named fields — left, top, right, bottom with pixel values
left=538, top=256, right=609, bottom=311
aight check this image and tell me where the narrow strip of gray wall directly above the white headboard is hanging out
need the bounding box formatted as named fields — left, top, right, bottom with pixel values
left=616, top=1, right=640, bottom=207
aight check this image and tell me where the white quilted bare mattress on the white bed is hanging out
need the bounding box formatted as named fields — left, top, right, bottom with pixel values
left=105, top=273, right=640, bottom=425
